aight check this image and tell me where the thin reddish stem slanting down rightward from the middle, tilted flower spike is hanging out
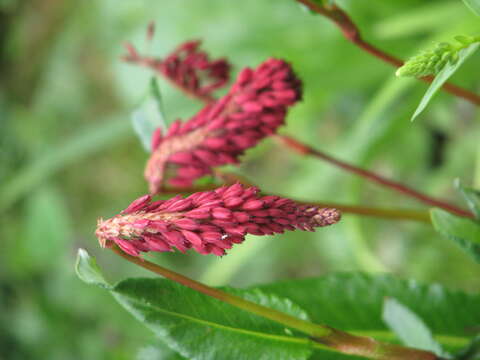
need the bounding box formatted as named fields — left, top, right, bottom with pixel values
left=275, top=135, right=473, bottom=218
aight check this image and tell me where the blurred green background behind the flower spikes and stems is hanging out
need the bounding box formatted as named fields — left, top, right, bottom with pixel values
left=0, top=0, right=480, bottom=360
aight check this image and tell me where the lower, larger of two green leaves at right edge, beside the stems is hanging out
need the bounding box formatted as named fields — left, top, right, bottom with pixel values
left=430, top=209, right=480, bottom=262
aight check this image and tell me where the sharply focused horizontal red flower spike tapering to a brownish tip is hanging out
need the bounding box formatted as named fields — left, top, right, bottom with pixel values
left=95, top=184, right=340, bottom=256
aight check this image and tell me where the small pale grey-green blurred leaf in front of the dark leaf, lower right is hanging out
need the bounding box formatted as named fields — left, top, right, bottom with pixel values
left=382, top=298, right=445, bottom=356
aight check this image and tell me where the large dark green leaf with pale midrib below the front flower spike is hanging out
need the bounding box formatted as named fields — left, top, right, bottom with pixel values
left=112, top=278, right=312, bottom=360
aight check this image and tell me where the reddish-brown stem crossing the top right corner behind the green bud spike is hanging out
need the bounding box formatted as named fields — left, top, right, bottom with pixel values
left=296, top=0, right=480, bottom=105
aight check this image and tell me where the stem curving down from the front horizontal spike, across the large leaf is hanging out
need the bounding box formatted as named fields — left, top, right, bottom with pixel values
left=111, top=246, right=440, bottom=360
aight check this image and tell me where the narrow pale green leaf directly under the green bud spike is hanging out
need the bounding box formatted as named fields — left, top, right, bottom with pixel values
left=411, top=42, right=480, bottom=121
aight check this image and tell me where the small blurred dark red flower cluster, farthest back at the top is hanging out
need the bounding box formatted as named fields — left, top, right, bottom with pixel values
left=123, top=41, right=230, bottom=100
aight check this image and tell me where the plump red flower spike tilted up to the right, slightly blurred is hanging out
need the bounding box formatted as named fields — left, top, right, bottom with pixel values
left=145, top=58, right=302, bottom=194
